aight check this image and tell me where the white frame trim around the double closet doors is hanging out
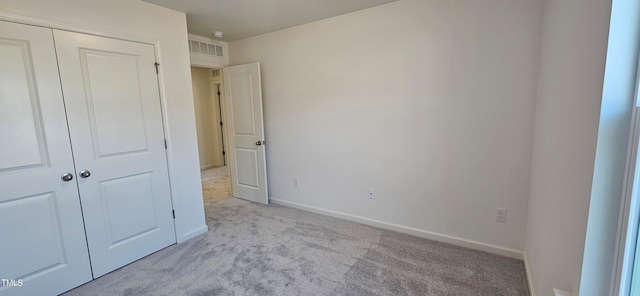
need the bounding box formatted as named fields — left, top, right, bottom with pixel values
left=0, top=11, right=180, bottom=243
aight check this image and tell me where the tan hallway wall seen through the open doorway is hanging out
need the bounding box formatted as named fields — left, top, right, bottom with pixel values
left=191, top=67, right=224, bottom=169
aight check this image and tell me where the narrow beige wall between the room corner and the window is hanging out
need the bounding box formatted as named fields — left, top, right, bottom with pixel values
left=525, top=0, right=614, bottom=296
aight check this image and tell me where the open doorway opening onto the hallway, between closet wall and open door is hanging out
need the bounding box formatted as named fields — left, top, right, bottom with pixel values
left=191, top=67, right=232, bottom=203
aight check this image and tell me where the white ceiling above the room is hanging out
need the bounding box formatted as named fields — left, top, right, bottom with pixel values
left=144, top=0, right=397, bottom=41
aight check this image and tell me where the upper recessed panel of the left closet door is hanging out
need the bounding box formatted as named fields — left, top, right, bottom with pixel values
left=0, top=37, right=46, bottom=171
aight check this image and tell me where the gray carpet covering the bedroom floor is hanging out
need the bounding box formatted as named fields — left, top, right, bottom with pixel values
left=65, top=198, right=528, bottom=296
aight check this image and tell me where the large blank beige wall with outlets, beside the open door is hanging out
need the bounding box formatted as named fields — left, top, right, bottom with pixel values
left=229, top=0, right=542, bottom=252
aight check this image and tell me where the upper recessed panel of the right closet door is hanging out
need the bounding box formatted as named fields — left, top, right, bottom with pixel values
left=80, top=49, right=147, bottom=157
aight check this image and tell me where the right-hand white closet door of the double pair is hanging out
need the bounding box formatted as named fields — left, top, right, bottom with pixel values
left=54, top=30, right=176, bottom=277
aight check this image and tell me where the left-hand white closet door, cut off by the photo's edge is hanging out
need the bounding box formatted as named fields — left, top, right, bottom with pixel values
left=0, top=22, right=91, bottom=296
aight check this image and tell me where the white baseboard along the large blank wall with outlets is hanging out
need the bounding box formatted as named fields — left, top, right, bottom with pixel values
left=269, top=197, right=524, bottom=260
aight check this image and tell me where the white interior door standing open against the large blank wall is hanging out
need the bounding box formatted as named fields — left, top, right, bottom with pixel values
left=223, top=63, right=269, bottom=204
